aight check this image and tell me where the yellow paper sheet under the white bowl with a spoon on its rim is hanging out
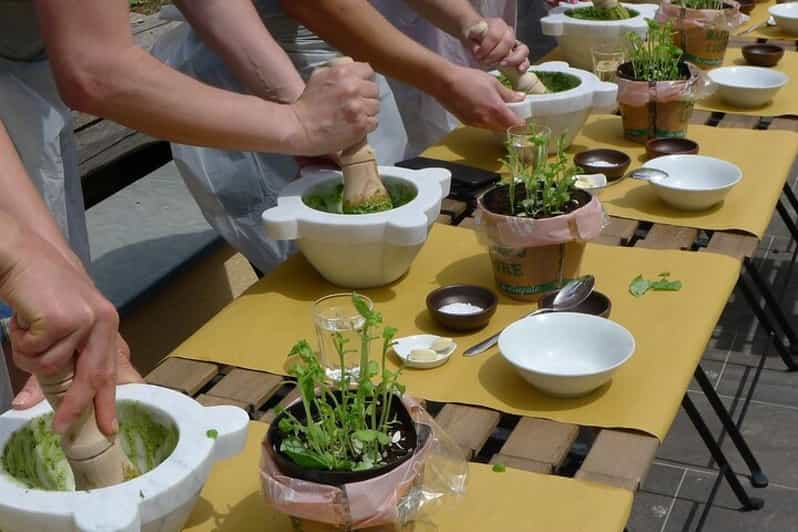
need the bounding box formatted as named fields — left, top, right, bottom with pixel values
left=424, top=115, right=798, bottom=238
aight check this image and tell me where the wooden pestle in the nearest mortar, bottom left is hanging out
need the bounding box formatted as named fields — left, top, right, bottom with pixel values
left=36, top=363, right=138, bottom=490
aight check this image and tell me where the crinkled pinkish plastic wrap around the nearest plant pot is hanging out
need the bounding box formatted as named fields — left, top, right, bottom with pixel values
left=260, top=396, right=468, bottom=530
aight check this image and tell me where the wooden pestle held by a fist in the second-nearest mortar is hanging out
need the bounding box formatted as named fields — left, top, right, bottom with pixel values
left=329, top=56, right=391, bottom=212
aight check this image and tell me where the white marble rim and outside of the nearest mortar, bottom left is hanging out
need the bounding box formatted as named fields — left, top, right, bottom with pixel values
left=0, top=384, right=248, bottom=532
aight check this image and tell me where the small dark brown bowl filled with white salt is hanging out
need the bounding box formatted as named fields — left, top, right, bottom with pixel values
left=427, top=284, right=499, bottom=331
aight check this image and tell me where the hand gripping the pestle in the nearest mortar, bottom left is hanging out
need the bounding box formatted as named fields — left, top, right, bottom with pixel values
left=0, top=211, right=119, bottom=435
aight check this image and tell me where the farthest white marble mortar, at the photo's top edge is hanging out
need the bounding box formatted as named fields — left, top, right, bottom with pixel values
left=540, top=2, right=659, bottom=71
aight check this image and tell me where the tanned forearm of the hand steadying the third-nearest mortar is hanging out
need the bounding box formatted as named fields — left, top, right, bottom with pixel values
left=281, top=0, right=453, bottom=96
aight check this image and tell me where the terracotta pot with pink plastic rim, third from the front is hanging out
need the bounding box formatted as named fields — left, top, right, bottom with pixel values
left=618, top=63, right=698, bottom=144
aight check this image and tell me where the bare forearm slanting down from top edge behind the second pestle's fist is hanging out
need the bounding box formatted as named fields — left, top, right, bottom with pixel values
left=175, top=0, right=305, bottom=103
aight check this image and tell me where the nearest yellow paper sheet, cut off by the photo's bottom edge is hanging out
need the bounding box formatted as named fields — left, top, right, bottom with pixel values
left=184, top=422, right=632, bottom=532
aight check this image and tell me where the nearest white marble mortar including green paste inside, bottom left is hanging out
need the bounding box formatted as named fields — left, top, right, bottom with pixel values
left=0, top=384, right=249, bottom=532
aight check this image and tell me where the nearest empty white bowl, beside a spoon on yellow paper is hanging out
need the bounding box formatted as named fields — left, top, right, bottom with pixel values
left=499, top=312, right=635, bottom=397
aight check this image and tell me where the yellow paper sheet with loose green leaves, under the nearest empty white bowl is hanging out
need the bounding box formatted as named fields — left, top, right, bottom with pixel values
left=174, top=224, right=740, bottom=439
